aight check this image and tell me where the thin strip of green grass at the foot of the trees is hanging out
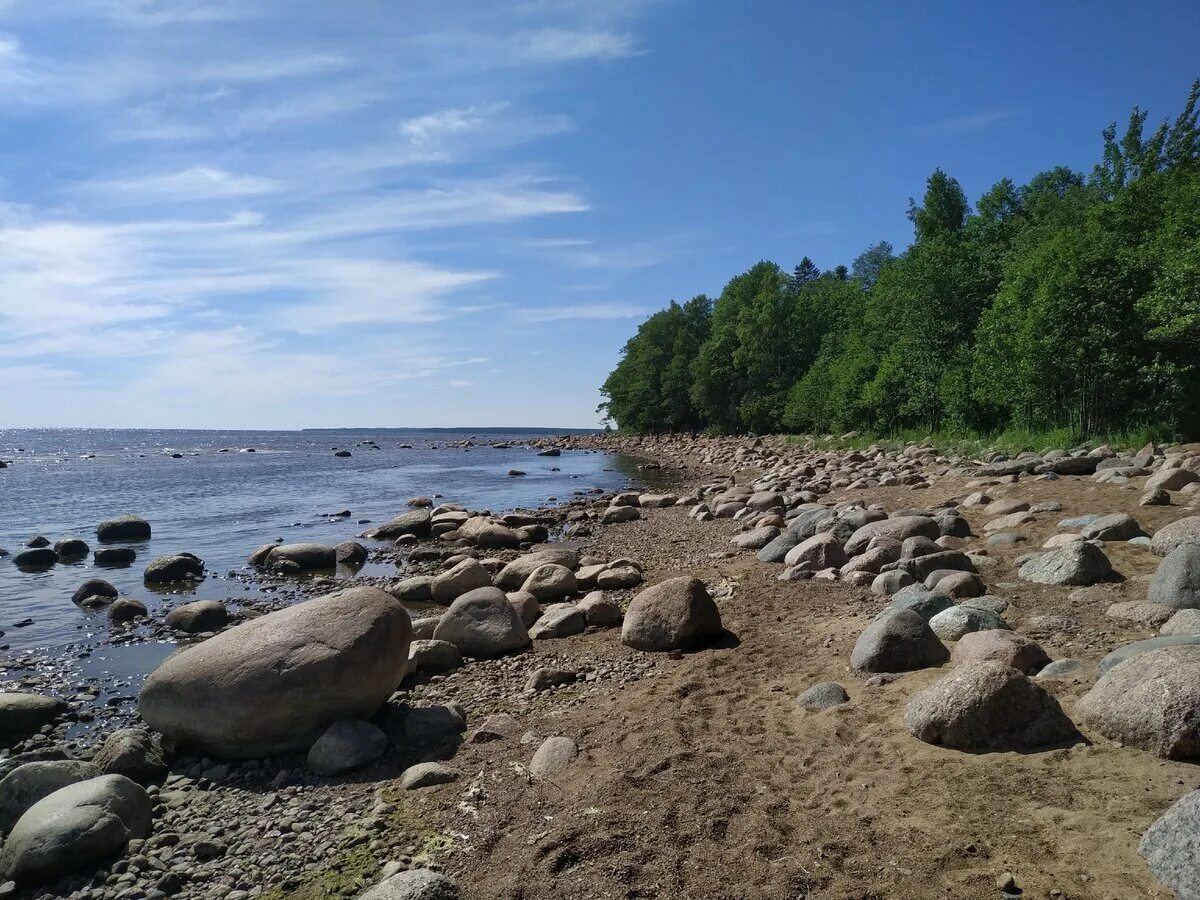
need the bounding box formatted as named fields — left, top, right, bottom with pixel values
left=788, top=427, right=1172, bottom=458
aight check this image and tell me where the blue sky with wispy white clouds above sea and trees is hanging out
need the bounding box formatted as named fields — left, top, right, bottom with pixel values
left=0, top=0, right=1200, bottom=428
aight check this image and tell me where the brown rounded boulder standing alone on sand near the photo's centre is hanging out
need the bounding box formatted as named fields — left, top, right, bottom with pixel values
left=620, top=576, right=725, bottom=650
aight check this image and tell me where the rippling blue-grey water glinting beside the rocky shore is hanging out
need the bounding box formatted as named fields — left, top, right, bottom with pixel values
left=0, top=430, right=637, bottom=657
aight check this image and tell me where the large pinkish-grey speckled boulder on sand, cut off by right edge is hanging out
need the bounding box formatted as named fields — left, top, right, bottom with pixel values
left=1075, top=646, right=1200, bottom=760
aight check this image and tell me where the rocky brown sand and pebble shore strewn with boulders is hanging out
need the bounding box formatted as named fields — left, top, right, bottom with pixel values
left=7, top=436, right=1200, bottom=900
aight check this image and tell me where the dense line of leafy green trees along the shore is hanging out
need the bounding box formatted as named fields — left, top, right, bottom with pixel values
left=600, top=79, right=1200, bottom=437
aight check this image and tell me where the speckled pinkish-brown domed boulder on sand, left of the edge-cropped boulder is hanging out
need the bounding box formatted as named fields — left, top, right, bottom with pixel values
left=904, top=660, right=1076, bottom=751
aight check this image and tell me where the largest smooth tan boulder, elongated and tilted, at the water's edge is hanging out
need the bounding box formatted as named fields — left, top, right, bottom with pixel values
left=138, top=587, right=410, bottom=758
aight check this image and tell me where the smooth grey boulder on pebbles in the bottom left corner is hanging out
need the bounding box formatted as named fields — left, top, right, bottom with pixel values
left=0, top=775, right=152, bottom=883
